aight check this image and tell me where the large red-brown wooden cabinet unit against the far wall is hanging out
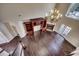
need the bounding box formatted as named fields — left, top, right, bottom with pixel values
left=24, top=18, right=46, bottom=35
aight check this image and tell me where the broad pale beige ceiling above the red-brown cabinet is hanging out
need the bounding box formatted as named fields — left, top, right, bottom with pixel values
left=0, top=3, right=55, bottom=21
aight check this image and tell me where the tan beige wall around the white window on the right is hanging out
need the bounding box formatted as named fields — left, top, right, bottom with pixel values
left=54, top=3, right=79, bottom=47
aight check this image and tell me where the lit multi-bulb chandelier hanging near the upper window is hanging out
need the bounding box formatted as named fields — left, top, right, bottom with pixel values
left=46, top=9, right=62, bottom=22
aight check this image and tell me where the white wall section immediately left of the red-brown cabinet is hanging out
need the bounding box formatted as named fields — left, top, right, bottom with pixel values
left=11, top=21, right=26, bottom=38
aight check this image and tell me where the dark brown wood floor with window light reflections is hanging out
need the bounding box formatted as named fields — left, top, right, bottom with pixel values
left=0, top=31, right=75, bottom=56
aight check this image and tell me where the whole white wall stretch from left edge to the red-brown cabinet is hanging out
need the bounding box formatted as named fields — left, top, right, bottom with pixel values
left=0, top=21, right=26, bottom=42
